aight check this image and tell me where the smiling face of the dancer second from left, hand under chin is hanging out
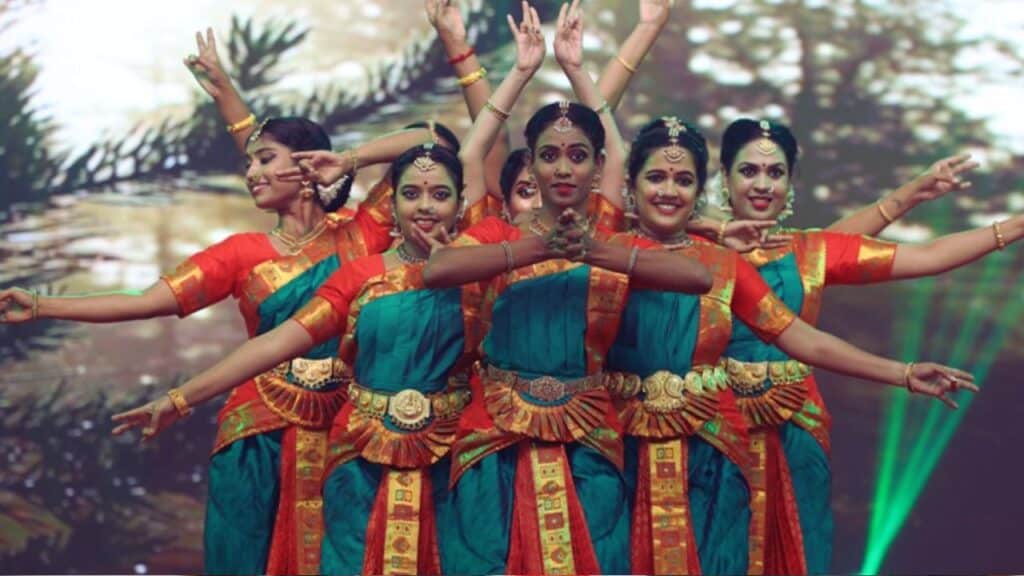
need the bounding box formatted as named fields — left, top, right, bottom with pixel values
left=394, top=162, right=459, bottom=240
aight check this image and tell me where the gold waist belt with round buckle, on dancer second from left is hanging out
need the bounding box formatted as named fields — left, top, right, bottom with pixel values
left=348, top=378, right=471, bottom=430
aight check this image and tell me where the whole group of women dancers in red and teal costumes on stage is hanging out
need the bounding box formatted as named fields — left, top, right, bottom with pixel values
left=0, top=0, right=1024, bottom=574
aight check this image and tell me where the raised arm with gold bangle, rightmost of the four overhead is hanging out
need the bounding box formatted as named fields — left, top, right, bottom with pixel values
left=597, top=0, right=673, bottom=110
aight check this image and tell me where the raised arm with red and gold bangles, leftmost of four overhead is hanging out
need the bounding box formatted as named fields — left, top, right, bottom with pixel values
left=424, top=0, right=509, bottom=198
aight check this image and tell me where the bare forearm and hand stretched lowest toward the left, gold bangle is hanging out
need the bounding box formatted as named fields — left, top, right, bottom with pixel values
left=113, top=320, right=313, bottom=441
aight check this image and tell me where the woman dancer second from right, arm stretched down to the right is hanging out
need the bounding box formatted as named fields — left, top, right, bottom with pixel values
left=607, top=117, right=975, bottom=574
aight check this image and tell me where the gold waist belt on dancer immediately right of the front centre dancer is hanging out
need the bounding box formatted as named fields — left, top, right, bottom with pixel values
left=606, top=365, right=726, bottom=412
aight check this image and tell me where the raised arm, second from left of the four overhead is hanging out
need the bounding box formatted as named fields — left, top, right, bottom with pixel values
left=459, top=2, right=545, bottom=205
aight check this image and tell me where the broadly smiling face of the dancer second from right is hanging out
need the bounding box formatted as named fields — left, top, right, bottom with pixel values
left=634, top=148, right=699, bottom=239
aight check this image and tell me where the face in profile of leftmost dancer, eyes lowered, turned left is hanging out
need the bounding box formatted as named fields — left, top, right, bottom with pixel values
left=246, top=134, right=302, bottom=211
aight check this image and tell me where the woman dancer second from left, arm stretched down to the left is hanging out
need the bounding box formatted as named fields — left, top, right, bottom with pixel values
left=110, top=140, right=482, bottom=574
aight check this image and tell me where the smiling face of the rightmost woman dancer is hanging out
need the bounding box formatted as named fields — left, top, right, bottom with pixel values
left=726, top=140, right=790, bottom=220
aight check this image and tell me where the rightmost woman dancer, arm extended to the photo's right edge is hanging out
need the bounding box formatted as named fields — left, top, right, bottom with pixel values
left=721, top=119, right=1024, bottom=574
